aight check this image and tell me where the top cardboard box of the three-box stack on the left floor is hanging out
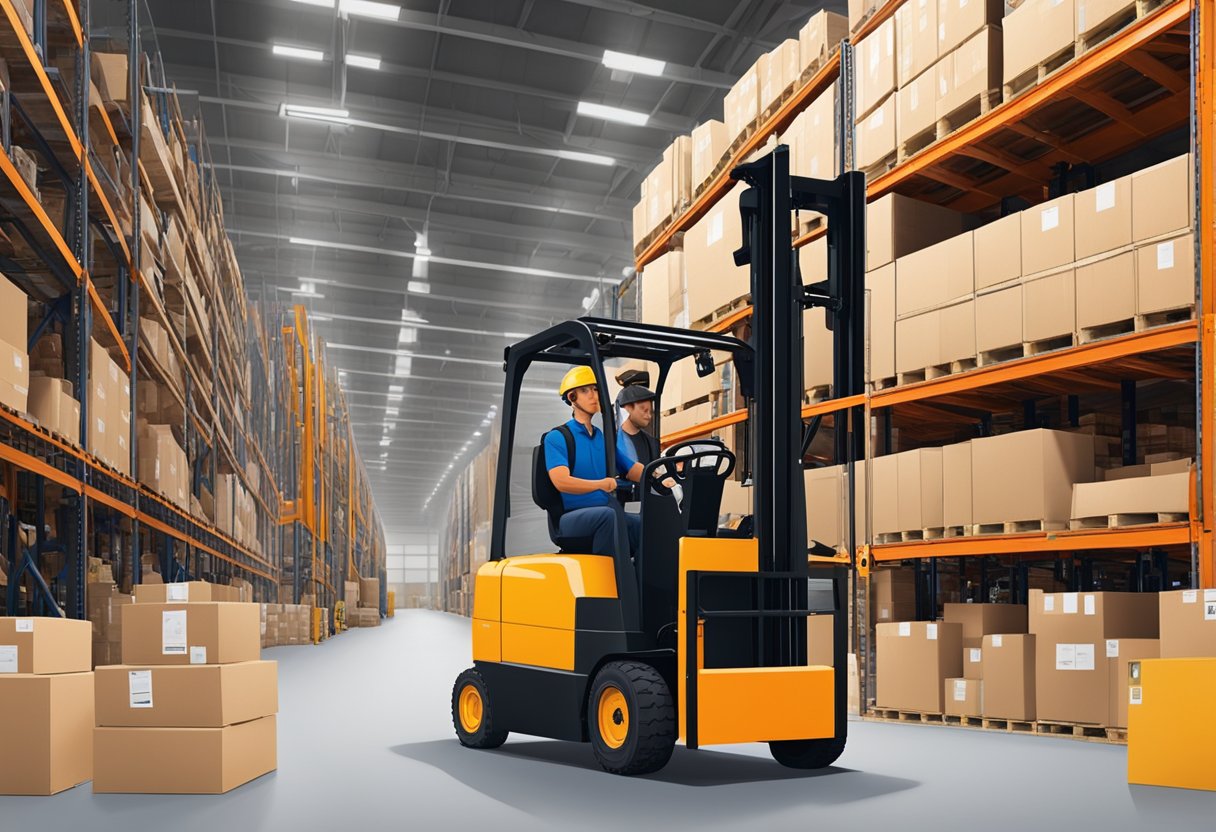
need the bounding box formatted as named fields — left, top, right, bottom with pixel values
left=123, top=602, right=261, bottom=664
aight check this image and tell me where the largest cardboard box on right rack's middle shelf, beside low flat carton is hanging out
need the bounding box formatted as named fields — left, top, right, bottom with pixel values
left=972, top=429, right=1093, bottom=524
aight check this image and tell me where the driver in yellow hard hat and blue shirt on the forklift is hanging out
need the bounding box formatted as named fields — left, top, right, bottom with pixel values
left=545, top=366, right=643, bottom=556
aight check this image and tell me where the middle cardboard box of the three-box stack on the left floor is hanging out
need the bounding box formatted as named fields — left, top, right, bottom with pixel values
left=96, top=662, right=278, bottom=727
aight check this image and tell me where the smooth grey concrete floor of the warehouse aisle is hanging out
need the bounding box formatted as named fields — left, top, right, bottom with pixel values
left=0, top=611, right=1216, bottom=832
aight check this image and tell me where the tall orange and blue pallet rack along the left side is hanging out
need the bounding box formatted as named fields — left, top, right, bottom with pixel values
left=0, top=0, right=384, bottom=618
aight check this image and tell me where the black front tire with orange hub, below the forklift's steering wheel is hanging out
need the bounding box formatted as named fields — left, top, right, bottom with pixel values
left=587, top=662, right=676, bottom=776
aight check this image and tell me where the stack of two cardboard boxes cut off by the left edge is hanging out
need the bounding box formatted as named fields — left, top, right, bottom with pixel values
left=0, top=618, right=94, bottom=794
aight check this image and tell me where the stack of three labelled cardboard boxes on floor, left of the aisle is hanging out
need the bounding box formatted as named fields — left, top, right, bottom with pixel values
left=94, top=598, right=278, bottom=794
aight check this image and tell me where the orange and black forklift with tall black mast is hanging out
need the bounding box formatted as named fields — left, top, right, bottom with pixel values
left=452, top=146, right=866, bottom=775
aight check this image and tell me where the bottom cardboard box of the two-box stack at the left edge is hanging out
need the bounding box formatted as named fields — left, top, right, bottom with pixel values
left=0, top=673, right=94, bottom=796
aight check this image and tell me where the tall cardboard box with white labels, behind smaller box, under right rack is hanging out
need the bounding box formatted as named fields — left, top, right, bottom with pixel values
left=1030, top=590, right=1159, bottom=725
